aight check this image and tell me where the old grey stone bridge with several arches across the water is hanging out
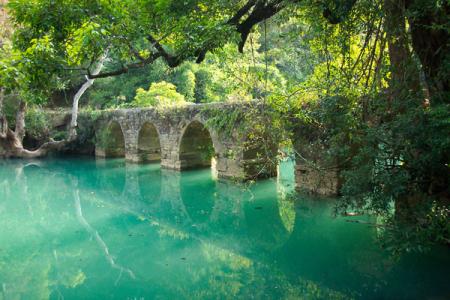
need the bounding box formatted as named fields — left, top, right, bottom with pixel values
left=95, top=102, right=338, bottom=195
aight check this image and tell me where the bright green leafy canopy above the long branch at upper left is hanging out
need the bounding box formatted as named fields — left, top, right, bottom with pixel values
left=1, top=0, right=251, bottom=101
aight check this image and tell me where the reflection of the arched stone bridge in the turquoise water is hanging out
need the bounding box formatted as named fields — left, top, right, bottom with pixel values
left=94, top=163, right=295, bottom=251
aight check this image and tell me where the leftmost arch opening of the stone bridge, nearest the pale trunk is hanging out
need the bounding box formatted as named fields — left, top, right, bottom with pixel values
left=95, top=121, right=125, bottom=158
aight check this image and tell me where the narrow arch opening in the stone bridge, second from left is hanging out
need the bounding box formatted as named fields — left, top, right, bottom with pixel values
left=138, top=122, right=161, bottom=162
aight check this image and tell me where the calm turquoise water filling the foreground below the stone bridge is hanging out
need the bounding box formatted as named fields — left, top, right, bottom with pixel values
left=0, top=158, right=450, bottom=300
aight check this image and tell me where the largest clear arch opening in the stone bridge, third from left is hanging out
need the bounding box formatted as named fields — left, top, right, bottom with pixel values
left=179, top=121, right=214, bottom=169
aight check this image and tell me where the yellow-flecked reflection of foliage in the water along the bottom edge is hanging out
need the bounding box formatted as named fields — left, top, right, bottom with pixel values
left=143, top=239, right=349, bottom=299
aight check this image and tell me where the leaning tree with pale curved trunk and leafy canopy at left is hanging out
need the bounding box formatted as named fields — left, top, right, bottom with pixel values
left=0, top=0, right=296, bottom=157
